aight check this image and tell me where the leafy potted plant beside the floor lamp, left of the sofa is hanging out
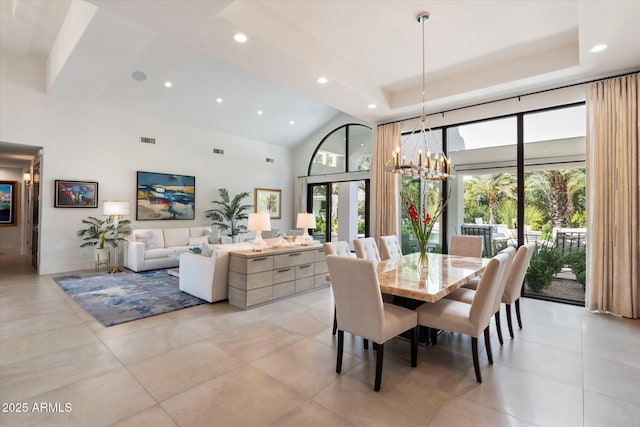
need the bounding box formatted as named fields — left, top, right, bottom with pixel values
left=77, top=216, right=131, bottom=261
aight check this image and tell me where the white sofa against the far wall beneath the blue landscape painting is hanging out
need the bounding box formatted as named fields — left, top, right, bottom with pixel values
left=124, top=227, right=231, bottom=272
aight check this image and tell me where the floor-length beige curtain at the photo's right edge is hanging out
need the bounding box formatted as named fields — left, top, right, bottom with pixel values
left=586, top=73, right=640, bottom=318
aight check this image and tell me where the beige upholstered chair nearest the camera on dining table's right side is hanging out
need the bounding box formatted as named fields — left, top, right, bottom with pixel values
left=416, top=254, right=509, bottom=383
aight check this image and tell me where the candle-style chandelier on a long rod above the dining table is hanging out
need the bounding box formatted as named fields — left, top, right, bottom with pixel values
left=384, top=12, right=454, bottom=181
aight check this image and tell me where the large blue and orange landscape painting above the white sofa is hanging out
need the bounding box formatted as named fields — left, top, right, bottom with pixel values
left=136, top=171, right=196, bottom=221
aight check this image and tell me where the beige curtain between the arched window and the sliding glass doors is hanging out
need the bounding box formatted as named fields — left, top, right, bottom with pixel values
left=371, top=123, right=400, bottom=237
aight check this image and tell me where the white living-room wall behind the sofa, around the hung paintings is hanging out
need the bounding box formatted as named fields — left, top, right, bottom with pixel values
left=0, top=52, right=294, bottom=274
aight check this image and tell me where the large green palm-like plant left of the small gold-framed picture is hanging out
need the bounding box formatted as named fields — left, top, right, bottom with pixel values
left=204, top=188, right=252, bottom=241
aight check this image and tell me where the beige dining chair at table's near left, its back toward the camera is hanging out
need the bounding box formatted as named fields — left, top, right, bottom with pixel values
left=327, top=255, right=418, bottom=391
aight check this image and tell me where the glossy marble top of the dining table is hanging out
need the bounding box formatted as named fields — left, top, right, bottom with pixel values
left=377, top=253, right=489, bottom=302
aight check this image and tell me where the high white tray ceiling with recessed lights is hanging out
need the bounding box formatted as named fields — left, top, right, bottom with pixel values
left=0, top=0, right=640, bottom=151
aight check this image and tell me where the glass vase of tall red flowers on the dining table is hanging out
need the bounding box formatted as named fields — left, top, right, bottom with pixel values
left=400, top=185, right=449, bottom=269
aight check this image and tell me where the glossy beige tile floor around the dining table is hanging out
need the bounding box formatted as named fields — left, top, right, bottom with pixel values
left=0, top=256, right=640, bottom=426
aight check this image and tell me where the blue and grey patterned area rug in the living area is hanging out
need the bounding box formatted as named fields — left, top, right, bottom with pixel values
left=53, top=270, right=206, bottom=326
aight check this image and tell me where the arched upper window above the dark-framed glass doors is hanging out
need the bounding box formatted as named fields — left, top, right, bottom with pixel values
left=309, top=124, right=373, bottom=176
